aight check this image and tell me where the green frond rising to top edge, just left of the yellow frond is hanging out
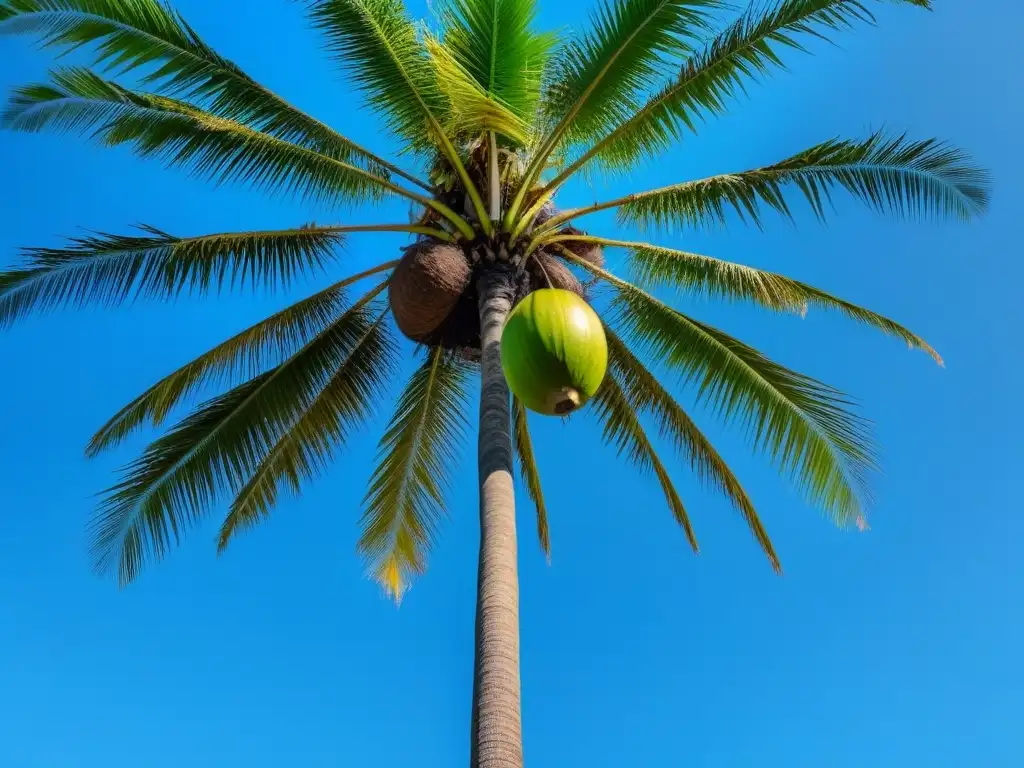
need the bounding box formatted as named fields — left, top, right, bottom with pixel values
left=306, top=0, right=490, bottom=233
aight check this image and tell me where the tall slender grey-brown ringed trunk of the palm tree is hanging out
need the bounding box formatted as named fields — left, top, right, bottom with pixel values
left=470, top=264, right=522, bottom=768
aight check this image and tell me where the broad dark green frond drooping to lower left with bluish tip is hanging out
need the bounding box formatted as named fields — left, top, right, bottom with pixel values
left=90, top=284, right=384, bottom=584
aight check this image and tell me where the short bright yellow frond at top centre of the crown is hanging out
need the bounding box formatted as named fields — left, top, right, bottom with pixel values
left=426, top=36, right=529, bottom=145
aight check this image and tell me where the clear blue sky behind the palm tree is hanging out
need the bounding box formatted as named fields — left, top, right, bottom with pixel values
left=0, top=0, right=1024, bottom=768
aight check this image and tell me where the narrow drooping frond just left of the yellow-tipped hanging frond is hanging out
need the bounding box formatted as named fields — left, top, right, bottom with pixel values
left=217, top=309, right=397, bottom=552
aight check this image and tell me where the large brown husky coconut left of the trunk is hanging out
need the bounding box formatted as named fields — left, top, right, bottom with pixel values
left=388, top=242, right=470, bottom=341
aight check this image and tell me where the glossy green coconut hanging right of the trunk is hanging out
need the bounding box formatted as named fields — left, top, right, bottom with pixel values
left=502, top=288, right=608, bottom=416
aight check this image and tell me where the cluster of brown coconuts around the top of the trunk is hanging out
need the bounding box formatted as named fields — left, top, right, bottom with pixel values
left=388, top=221, right=604, bottom=358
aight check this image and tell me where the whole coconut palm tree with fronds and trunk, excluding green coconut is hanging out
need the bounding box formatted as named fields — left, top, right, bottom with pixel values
left=0, top=0, right=988, bottom=767
